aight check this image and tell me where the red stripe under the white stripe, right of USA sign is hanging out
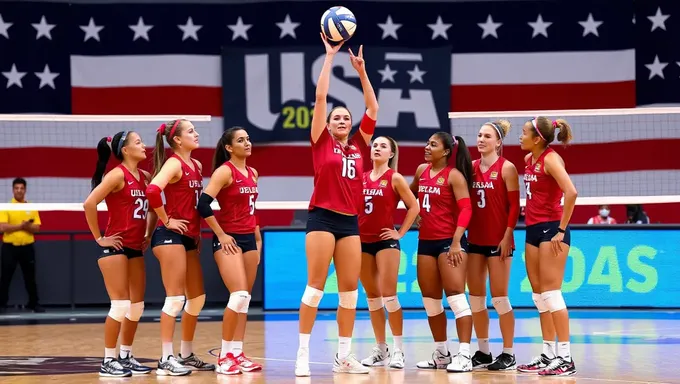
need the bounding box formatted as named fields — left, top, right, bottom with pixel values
left=451, top=81, right=635, bottom=112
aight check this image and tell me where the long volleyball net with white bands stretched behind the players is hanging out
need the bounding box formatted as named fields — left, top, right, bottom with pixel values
left=0, top=108, right=680, bottom=223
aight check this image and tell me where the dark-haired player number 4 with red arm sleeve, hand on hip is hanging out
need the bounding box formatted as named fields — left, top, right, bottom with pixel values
left=411, top=132, right=472, bottom=372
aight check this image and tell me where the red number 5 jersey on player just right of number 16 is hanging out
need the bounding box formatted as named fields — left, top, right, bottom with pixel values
left=359, top=169, right=400, bottom=243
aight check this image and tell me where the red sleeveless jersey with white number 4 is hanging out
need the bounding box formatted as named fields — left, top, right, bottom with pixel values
left=418, top=165, right=458, bottom=240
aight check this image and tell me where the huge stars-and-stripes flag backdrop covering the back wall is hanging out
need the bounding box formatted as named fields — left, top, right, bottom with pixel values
left=0, top=0, right=680, bottom=226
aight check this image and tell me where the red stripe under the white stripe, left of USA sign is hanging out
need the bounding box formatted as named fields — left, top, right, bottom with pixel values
left=71, top=86, right=222, bottom=116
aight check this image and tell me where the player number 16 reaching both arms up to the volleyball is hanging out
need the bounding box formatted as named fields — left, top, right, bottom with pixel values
left=295, top=34, right=378, bottom=376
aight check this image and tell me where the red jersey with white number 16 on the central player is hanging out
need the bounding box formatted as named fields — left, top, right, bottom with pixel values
left=309, top=115, right=375, bottom=215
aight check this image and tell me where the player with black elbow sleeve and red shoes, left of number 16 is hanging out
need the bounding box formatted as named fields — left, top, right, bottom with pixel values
left=198, top=127, right=262, bottom=375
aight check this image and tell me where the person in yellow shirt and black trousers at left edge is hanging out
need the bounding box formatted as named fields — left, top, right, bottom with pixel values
left=0, top=177, right=45, bottom=312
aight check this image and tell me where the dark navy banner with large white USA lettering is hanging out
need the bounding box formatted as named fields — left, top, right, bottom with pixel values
left=222, top=45, right=451, bottom=143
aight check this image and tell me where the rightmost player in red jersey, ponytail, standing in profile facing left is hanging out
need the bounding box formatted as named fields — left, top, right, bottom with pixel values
left=517, top=116, right=577, bottom=376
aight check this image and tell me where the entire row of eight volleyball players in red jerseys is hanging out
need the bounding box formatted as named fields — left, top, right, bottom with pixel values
left=84, top=36, right=576, bottom=377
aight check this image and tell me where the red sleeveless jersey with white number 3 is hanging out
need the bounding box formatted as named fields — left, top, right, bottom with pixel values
left=468, top=157, right=510, bottom=246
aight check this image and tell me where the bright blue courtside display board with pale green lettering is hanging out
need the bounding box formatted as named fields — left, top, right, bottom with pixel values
left=263, top=229, right=680, bottom=310
